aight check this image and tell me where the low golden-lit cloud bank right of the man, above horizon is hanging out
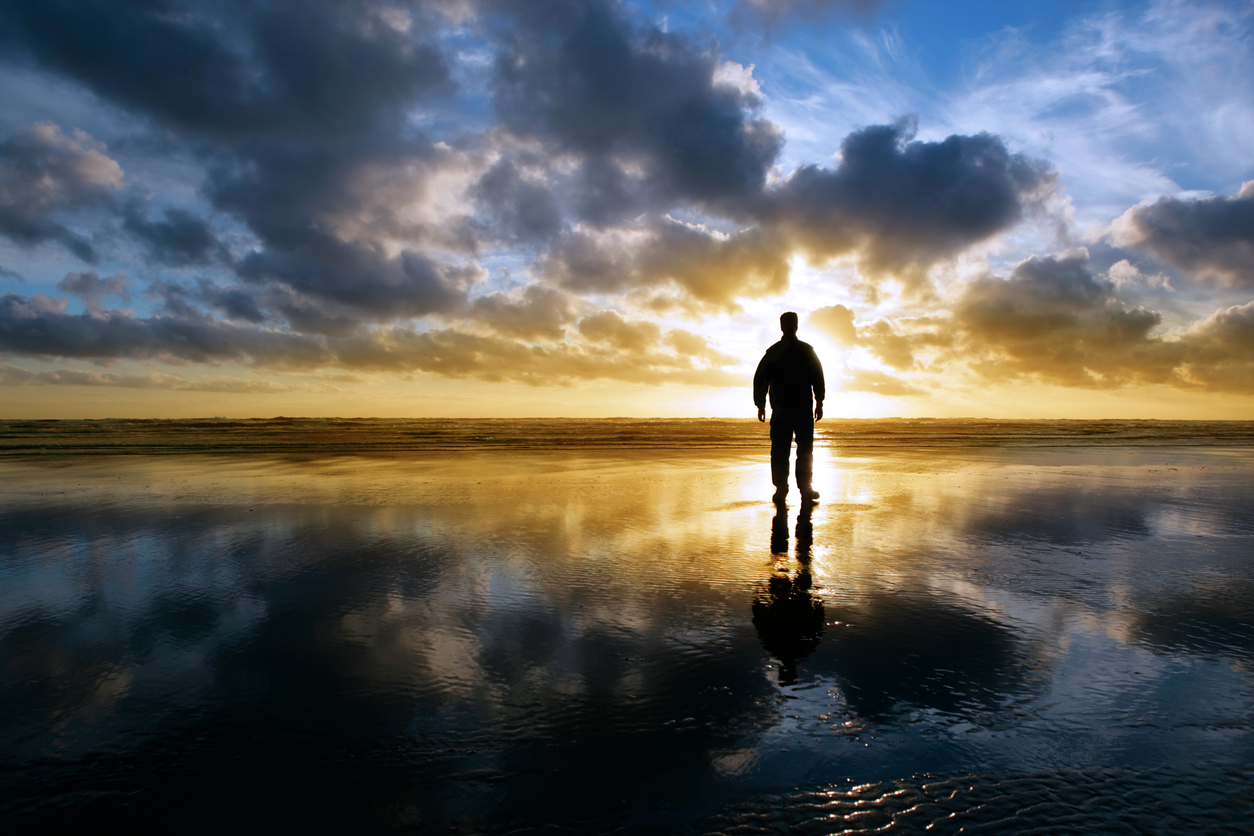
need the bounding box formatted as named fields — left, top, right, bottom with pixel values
left=810, top=249, right=1254, bottom=395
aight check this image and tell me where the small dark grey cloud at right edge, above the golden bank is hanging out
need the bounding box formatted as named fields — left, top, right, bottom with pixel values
left=1114, top=180, right=1254, bottom=288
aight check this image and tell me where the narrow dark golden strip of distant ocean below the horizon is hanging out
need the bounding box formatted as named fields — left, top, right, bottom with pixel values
left=0, top=417, right=1254, bottom=457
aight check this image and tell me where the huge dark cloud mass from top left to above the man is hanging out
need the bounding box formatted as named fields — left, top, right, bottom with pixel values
left=0, top=0, right=1052, bottom=337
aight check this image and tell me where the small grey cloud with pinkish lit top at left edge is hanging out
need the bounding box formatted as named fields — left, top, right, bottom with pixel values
left=0, top=122, right=123, bottom=262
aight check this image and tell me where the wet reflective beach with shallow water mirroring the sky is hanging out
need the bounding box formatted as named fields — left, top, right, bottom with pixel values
left=0, top=447, right=1254, bottom=833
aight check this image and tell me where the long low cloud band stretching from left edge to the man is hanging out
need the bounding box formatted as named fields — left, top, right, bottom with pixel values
left=0, top=293, right=746, bottom=386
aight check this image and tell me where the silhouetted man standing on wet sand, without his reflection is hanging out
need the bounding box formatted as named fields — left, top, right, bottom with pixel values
left=754, top=311, right=826, bottom=501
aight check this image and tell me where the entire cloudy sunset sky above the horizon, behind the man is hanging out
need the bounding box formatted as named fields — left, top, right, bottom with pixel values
left=0, top=0, right=1254, bottom=419
